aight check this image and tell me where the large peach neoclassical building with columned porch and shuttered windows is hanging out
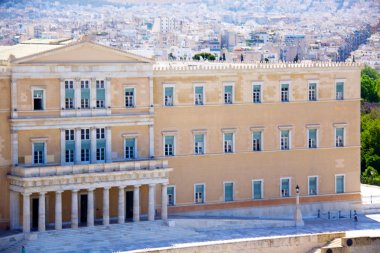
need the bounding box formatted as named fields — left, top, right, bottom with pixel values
left=0, top=41, right=362, bottom=232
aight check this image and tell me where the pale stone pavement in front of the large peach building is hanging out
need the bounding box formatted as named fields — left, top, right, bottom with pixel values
left=6, top=214, right=380, bottom=253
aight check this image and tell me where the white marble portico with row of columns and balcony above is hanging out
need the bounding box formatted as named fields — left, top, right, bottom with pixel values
left=9, top=160, right=171, bottom=233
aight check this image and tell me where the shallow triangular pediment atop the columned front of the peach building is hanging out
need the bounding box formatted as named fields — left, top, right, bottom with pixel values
left=13, top=41, right=153, bottom=64
